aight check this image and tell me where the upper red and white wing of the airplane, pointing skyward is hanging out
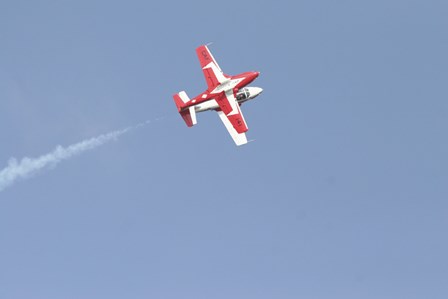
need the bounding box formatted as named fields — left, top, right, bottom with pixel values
left=196, top=45, right=227, bottom=90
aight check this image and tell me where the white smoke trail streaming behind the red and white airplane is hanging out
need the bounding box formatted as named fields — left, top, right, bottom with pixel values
left=0, top=121, right=155, bottom=192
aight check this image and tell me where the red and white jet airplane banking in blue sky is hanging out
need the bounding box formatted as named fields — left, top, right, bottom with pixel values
left=173, top=45, right=263, bottom=146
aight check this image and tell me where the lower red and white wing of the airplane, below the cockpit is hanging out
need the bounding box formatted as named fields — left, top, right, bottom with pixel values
left=217, top=91, right=248, bottom=145
